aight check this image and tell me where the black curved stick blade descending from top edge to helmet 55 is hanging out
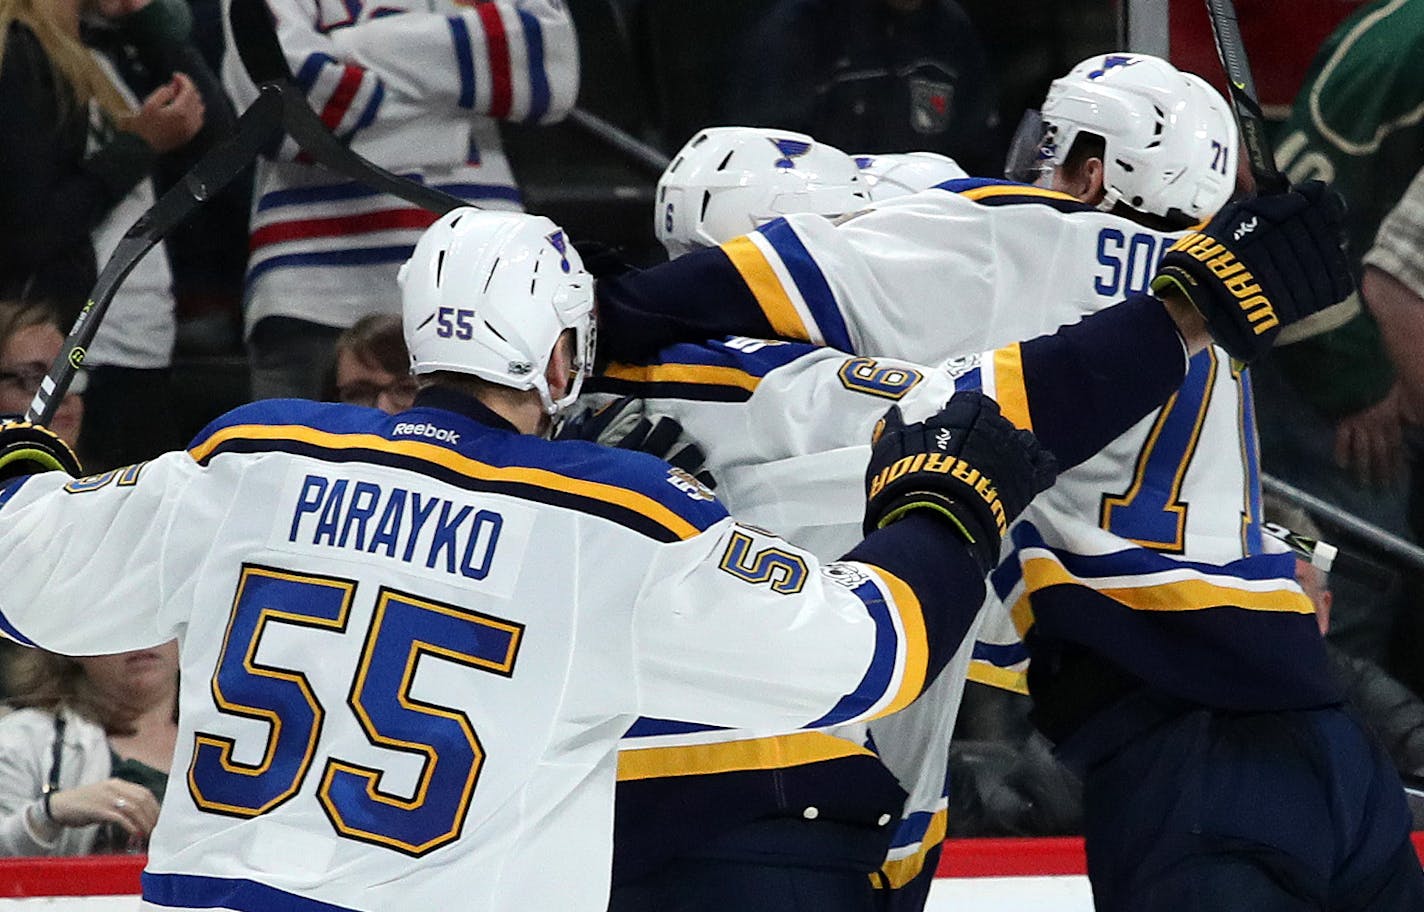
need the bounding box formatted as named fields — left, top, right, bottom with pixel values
left=228, top=0, right=464, bottom=215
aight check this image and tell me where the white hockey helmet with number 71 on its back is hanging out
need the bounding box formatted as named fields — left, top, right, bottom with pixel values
left=1038, top=54, right=1237, bottom=221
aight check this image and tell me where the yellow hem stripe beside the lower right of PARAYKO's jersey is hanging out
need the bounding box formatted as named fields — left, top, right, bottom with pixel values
left=618, top=731, right=874, bottom=782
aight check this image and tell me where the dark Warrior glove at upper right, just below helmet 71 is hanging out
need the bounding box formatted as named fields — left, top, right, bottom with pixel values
left=1152, top=181, right=1354, bottom=362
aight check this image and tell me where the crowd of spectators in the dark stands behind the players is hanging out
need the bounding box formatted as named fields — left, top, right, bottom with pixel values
left=0, top=0, right=1424, bottom=854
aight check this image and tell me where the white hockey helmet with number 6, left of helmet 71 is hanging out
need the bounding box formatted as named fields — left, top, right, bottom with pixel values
left=654, top=127, right=870, bottom=258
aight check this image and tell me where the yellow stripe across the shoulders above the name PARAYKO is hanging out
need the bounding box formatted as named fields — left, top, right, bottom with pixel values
left=188, top=425, right=698, bottom=540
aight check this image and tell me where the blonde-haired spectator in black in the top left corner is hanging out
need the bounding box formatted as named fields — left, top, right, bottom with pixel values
left=0, top=0, right=204, bottom=311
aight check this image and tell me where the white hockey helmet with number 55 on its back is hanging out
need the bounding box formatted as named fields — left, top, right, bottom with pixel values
left=397, top=208, right=594, bottom=415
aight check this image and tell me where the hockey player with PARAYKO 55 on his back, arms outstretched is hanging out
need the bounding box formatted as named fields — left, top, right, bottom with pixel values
left=0, top=209, right=1052, bottom=912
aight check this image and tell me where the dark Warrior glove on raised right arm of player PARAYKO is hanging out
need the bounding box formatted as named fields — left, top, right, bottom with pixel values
left=864, top=390, right=1058, bottom=573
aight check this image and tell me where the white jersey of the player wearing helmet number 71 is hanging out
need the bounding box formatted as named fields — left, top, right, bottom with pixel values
left=600, top=180, right=1336, bottom=710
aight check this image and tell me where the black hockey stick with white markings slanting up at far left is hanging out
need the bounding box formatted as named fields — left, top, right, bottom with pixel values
left=24, top=88, right=283, bottom=425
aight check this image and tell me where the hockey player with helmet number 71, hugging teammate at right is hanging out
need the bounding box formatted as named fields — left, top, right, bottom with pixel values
left=601, top=54, right=1424, bottom=911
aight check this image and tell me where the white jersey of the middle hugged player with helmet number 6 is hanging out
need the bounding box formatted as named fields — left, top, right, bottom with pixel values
left=591, top=290, right=1186, bottom=888
